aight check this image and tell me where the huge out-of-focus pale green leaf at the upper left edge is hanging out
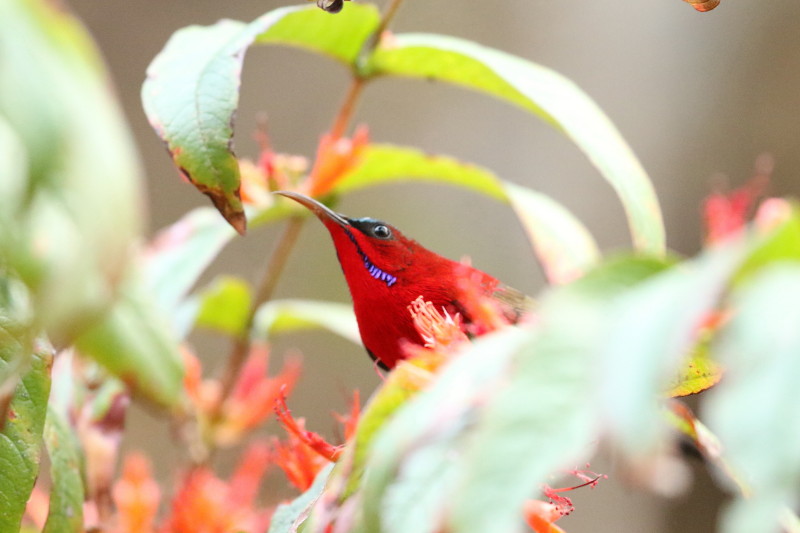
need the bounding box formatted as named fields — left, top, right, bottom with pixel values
left=0, top=0, right=142, bottom=345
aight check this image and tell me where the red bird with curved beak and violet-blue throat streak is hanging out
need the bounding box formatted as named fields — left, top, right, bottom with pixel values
left=275, top=191, right=528, bottom=370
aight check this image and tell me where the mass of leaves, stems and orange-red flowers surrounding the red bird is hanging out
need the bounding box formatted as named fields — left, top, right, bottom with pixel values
left=0, top=0, right=800, bottom=533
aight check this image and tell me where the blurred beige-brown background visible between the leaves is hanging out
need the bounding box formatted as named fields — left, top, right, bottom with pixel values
left=68, top=0, right=800, bottom=533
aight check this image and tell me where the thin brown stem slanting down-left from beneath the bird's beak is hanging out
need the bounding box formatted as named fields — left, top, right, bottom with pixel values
left=211, top=217, right=305, bottom=412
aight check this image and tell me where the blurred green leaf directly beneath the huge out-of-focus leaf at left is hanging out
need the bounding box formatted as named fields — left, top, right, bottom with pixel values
left=76, top=279, right=183, bottom=407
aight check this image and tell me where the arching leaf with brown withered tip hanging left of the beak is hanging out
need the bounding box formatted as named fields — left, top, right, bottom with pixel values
left=142, top=6, right=378, bottom=233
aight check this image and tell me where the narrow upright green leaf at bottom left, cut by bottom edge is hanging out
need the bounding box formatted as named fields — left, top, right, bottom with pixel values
left=43, top=409, right=84, bottom=533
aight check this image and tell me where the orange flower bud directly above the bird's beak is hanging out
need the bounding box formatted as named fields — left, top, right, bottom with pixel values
left=306, top=126, right=369, bottom=198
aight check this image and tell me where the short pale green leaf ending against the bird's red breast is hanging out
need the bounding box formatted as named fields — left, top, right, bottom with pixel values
left=254, top=300, right=361, bottom=345
